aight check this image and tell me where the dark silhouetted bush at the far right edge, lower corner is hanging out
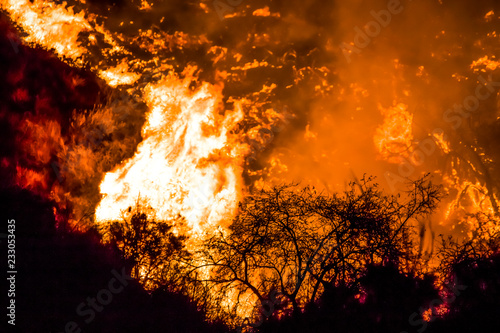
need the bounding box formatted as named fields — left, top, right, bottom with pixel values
left=422, top=212, right=500, bottom=332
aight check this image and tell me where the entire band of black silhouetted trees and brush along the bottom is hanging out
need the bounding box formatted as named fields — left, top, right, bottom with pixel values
left=1, top=175, right=500, bottom=333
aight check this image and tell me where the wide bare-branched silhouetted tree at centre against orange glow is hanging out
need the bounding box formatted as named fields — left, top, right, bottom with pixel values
left=194, top=177, right=441, bottom=324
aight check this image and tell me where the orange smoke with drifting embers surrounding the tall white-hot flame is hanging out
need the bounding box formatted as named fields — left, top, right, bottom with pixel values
left=2, top=0, right=500, bottom=236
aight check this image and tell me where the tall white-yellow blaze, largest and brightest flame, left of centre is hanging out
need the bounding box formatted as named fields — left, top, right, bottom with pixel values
left=96, top=70, right=246, bottom=232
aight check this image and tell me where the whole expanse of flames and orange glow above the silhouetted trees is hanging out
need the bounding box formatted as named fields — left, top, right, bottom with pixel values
left=0, top=0, right=500, bottom=324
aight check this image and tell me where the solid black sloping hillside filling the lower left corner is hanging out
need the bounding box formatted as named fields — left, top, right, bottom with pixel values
left=0, top=188, right=225, bottom=333
